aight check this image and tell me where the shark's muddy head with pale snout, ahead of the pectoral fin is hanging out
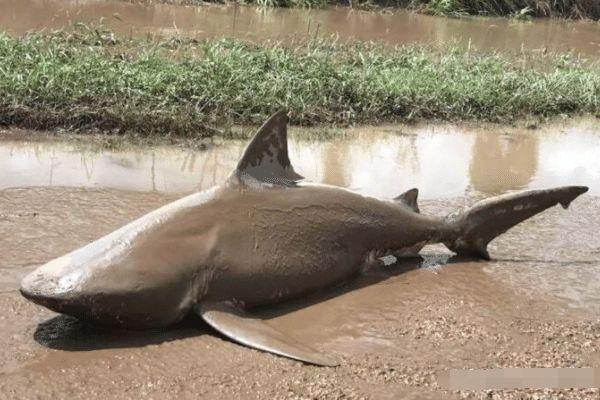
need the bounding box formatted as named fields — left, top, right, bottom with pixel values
left=20, top=194, right=214, bottom=328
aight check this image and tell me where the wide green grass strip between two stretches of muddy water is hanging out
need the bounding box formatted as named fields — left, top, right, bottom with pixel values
left=0, top=28, right=600, bottom=136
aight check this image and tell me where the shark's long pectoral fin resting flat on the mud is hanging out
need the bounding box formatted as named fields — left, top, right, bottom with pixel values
left=194, top=302, right=338, bottom=367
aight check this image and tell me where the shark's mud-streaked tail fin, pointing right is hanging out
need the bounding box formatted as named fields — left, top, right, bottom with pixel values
left=444, top=186, right=588, bottom=260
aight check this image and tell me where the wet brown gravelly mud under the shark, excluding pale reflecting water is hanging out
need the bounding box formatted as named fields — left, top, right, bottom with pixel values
left=0, top=187, right=600, bottom=400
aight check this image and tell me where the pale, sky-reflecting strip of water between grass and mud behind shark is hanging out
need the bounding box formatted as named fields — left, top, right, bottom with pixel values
left=0, top=119, right=600, bottom=198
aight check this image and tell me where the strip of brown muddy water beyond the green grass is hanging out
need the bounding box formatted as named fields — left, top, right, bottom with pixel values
left=0, top=0, right=600, bottom=56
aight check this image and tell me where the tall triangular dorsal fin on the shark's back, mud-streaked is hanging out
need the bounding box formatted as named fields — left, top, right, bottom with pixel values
left=231, top=110, right=303, bottom=186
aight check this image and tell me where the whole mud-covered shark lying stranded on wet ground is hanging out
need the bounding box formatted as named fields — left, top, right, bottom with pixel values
left=21, top=112, right=587, bottom=365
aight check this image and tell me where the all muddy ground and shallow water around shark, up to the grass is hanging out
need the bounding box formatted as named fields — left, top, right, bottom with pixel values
left=0, top=119, right=600, bottom=399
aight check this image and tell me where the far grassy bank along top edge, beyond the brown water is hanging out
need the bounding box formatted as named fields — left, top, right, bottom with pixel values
left=127, top=0, right=600, bottom=19
